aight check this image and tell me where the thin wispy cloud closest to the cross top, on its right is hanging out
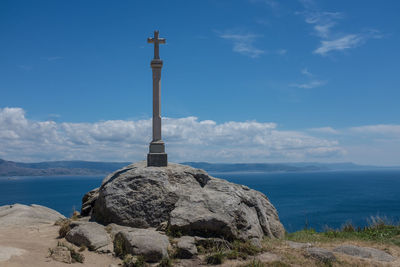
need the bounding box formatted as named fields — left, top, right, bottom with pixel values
left=219, top=33, right=265, bottom=58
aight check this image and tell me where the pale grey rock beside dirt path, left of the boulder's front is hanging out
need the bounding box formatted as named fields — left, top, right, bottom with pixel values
left=65, top=222, right=111, bottom=250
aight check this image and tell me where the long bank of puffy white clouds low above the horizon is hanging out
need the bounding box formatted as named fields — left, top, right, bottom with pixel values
left=0, top=108, right=345, bottom=162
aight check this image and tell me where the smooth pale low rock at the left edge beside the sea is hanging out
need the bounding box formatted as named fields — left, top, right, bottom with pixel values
left=0, top=204, right=65, bottom=226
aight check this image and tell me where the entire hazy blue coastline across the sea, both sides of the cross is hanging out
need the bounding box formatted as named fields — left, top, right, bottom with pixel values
left=0, top=159, right=400, bottom=177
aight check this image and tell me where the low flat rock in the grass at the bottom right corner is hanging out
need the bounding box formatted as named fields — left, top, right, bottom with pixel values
left=333, top=245, right=396, bottom=262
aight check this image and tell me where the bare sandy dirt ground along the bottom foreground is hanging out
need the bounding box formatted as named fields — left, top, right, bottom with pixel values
left=0, top=225, right=400, bottom=267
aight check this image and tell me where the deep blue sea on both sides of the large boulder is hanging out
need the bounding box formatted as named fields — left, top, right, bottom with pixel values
left=0, top=170, right=400, bottom=232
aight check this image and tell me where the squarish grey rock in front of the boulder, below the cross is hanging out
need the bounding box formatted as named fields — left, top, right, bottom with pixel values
left=114, top=228, right=169, bottom=262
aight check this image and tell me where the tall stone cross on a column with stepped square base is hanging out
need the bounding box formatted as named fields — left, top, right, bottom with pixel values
left=147, top=31, right=168, bottom=167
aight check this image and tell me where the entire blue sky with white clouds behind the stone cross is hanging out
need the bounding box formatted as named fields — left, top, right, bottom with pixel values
left=0, top=0, right=400, bottom=165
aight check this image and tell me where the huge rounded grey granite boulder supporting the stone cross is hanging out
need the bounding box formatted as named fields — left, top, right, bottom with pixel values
left=82, top=161, right=284, bottom=240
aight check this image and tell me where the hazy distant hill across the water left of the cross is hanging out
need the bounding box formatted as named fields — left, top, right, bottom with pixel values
left=0, top=159, right=130, bottom=176
